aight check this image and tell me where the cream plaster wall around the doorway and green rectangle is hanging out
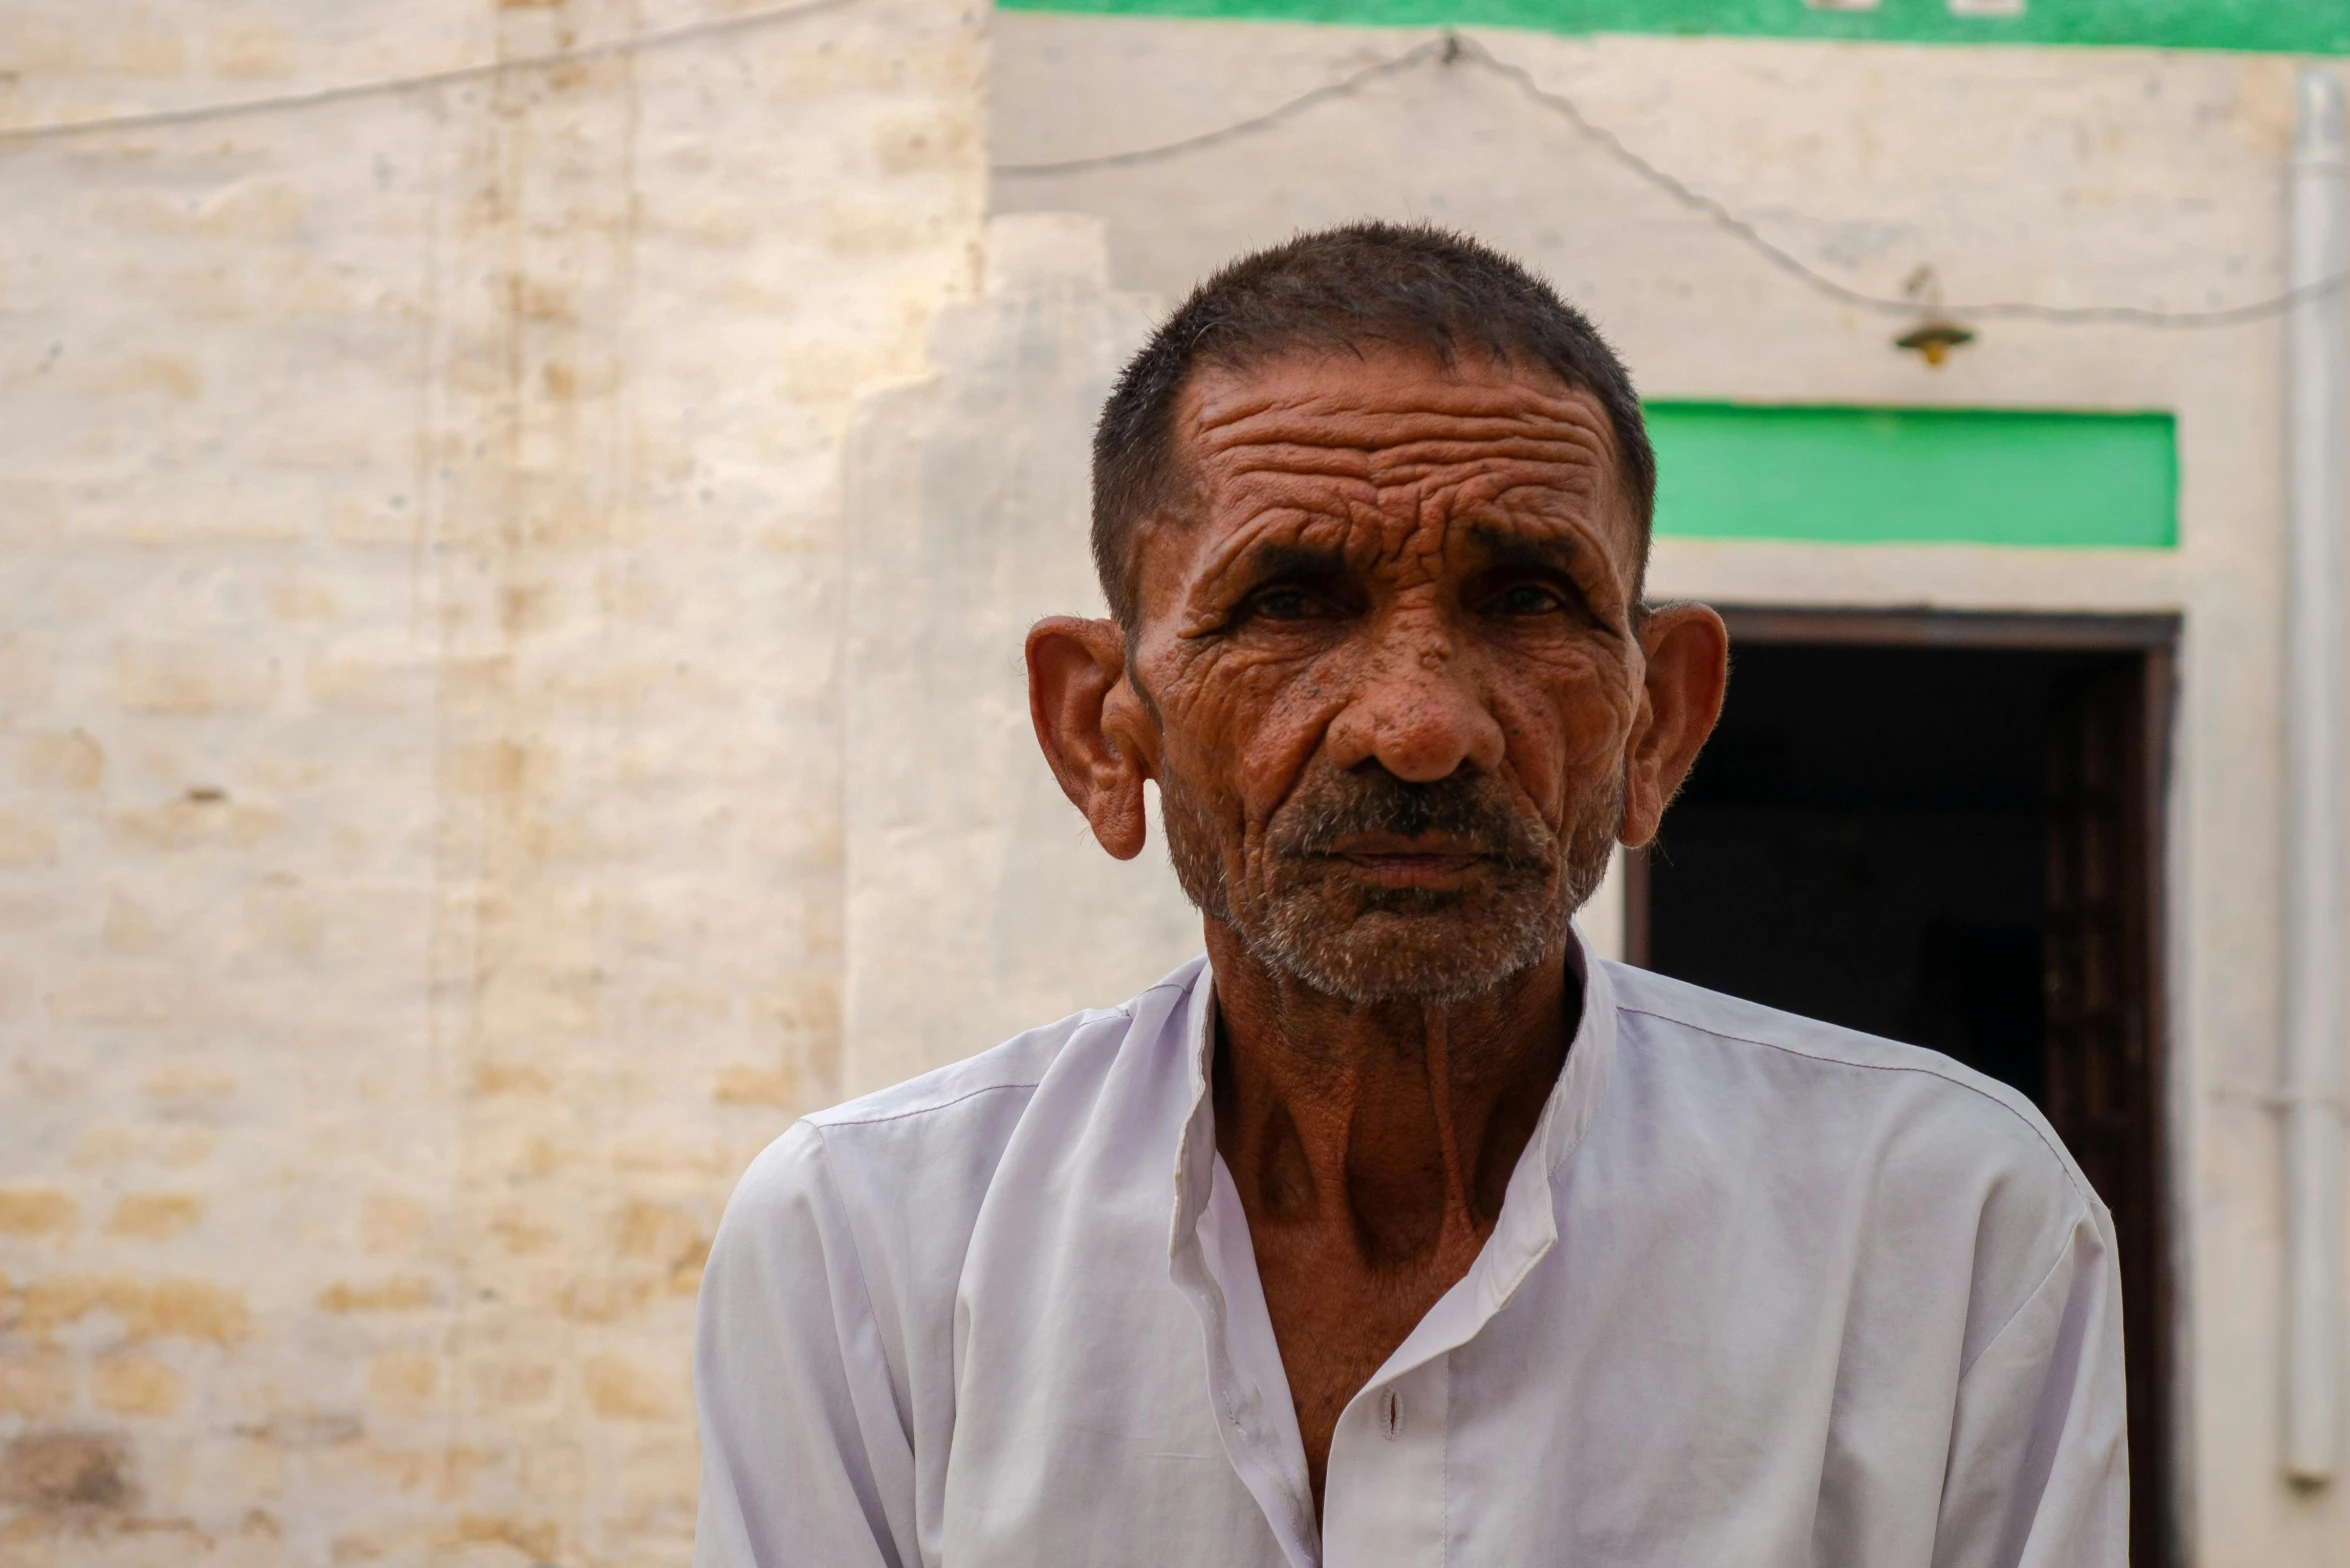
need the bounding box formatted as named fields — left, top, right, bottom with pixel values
left=992, top=14, right=2350, bottom=1568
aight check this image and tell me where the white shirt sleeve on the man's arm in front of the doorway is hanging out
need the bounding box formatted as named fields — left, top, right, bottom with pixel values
left=1934, top=1201, right=2129, bottom=1568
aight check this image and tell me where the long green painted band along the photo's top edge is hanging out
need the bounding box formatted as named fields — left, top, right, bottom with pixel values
left=999, top=0, right=2350, bottom=54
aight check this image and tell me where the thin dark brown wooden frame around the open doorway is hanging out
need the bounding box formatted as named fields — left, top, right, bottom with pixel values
left=1622, top=604, right=2190, bottom=1568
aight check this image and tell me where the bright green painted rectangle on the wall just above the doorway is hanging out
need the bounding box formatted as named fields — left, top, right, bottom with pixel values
left=1647, top=402, right=2178, bottom=550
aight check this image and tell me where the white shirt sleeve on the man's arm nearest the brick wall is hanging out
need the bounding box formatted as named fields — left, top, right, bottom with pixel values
left=693, top=1121, right=919, bottom=1568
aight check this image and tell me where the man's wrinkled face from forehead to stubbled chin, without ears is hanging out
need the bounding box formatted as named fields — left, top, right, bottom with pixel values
left=1128, top=350, right=1643, bottom=1001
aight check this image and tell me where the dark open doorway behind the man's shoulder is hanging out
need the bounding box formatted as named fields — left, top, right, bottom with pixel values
left=1626, top=611, right=2176, bottom=1568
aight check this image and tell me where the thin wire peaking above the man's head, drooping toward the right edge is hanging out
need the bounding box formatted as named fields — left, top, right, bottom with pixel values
left=992, top=33, right=2350, bottom=327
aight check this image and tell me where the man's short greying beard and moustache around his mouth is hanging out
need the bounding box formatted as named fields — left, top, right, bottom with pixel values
left=1161, top=773, right=1624, bottom=1006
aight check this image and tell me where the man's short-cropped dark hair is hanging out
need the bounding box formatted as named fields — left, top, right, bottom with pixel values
left=1093, top=223, right=1657, bottom=637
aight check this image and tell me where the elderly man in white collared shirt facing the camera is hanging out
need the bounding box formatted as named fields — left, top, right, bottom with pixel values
left=696, top=223, right=2127, bottom=1568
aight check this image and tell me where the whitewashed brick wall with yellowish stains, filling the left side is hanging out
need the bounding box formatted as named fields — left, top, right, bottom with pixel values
left=0, top=0, right=982, bottom=1568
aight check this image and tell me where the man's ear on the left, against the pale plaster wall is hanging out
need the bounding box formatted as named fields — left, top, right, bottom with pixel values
left=1027, top=616, right=1149, bottom=860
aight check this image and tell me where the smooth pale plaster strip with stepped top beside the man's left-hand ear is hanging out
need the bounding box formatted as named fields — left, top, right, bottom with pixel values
left=844, top=214, right=1199, bottom=1093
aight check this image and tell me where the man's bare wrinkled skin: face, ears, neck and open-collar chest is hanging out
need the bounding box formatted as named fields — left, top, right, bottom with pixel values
left=1027, top=350, right=1727, bottom=1502
